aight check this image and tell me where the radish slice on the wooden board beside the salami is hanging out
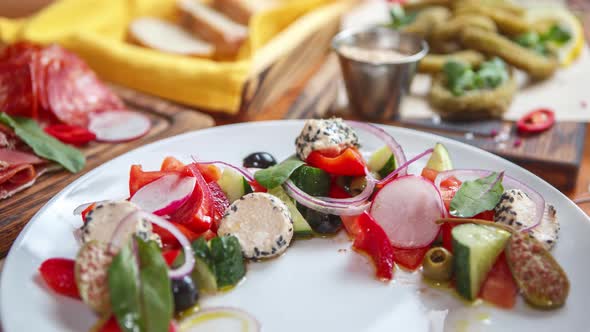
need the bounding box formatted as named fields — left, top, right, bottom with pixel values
left=88, top=110, right=152, bottom=142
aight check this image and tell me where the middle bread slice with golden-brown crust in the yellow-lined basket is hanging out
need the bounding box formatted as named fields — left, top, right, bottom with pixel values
left=177, top=0, right=248, bottom=56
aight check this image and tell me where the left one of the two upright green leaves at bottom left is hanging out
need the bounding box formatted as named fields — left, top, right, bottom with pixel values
left=108, top=241, right=143, bottom=332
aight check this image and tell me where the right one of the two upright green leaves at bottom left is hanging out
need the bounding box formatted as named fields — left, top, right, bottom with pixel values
left=136, top=238, right=174, bottom=332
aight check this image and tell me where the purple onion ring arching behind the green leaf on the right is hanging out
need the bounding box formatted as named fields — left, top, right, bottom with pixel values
left=434, top=169, right=545, bottom=231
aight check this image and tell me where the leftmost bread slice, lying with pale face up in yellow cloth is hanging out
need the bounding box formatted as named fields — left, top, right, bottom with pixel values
left=129, top=17, right=215, bottom=57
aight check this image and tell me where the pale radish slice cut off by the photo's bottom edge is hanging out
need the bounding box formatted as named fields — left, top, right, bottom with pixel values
left=179, top=307, right=260, bottom=332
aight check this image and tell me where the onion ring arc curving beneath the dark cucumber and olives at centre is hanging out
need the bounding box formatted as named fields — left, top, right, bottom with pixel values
left=283, top=180, right=371, bottom=216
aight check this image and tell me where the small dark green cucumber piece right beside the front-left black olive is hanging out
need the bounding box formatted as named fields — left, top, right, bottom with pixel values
left=192, top=237, right=217, bottom=293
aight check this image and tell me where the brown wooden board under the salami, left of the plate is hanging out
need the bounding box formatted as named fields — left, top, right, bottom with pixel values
left=0, top=86, right=215, bottom=257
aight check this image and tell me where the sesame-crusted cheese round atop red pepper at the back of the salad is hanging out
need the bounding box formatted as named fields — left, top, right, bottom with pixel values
left=295, top=118, right=359, bottom=160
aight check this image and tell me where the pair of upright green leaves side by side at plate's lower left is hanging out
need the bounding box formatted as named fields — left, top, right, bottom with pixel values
left=108, top=237, right=173, bottom=332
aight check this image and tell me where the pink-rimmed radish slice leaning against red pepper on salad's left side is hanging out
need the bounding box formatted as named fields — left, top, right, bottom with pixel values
left=129, top=174, right=196, bottom=216
